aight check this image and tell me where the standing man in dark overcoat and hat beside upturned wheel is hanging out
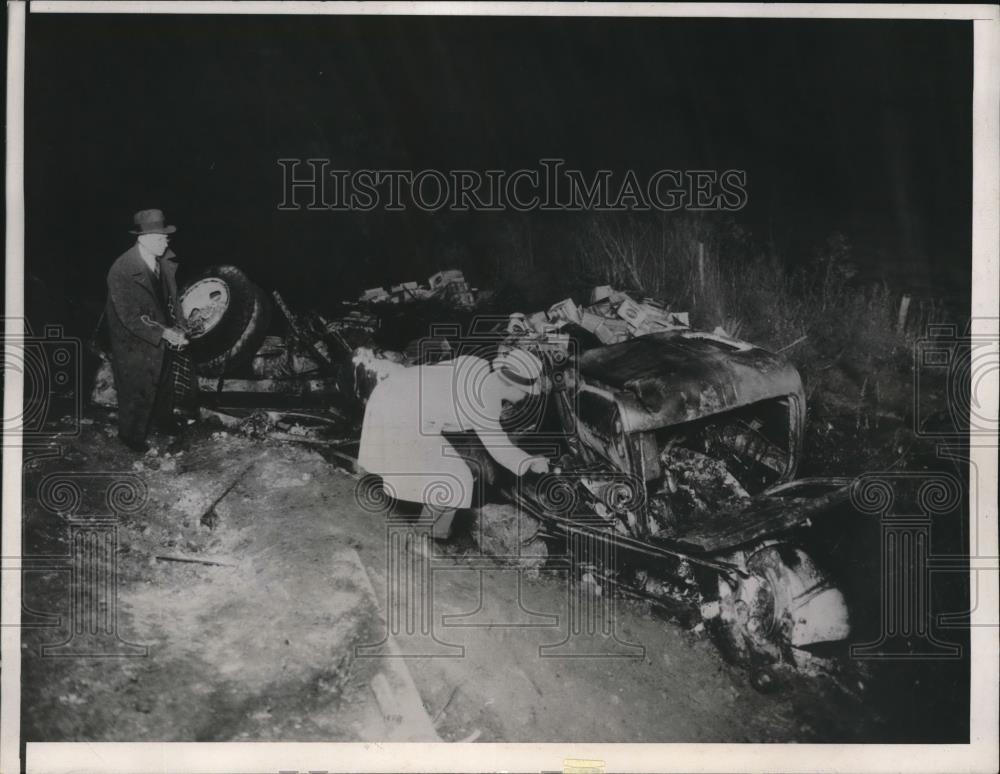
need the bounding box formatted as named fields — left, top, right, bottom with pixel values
left=105, top=210, right=188, bottom=452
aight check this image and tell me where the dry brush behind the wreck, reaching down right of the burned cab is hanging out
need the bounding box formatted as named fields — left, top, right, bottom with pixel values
left=478, top=213, right=960, bottom=469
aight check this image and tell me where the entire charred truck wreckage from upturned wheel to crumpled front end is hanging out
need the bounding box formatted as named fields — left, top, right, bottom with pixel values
left=92, top=266, right=850, bottom=684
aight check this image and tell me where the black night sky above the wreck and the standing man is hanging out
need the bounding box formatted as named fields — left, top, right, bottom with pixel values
left=26, top=15, right=972, bottom=330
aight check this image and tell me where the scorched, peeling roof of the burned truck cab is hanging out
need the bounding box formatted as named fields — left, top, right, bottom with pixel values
left=578, top=331, right=802, bottom=432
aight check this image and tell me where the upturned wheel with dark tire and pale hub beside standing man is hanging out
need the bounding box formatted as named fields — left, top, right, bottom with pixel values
left=181, top=266, right=270, bottom=376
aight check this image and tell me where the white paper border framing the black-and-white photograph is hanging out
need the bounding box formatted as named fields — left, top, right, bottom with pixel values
left=0, top=0, right=1000, bottom=774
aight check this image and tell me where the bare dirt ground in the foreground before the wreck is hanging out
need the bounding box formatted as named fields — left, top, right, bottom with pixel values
left=15, top=410, right=964, bottom=742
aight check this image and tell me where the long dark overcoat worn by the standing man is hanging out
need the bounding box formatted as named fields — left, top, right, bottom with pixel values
left=105, top=244, right=180, bottom=440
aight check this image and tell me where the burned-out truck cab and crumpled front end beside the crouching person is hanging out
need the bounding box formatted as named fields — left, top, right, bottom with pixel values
left=430, top=328, right=850, bottom=680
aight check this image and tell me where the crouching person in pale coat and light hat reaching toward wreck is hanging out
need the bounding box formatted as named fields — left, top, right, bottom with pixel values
left=358, top=350, right=548, bottom=540
